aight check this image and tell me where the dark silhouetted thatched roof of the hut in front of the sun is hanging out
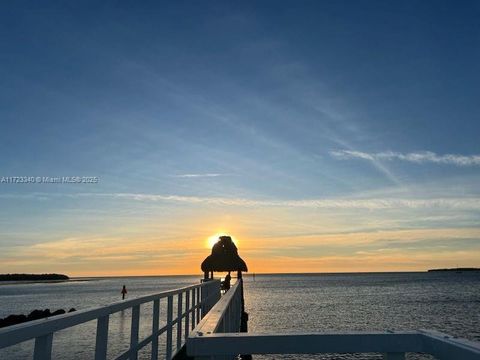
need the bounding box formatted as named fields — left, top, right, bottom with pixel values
left=202, top=236, right=248, bottom=272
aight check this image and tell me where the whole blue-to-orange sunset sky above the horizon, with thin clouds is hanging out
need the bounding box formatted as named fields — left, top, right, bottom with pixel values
left=0, top=0, right=480, bottom=276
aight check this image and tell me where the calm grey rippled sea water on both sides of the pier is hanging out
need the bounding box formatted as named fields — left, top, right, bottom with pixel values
left=0, top=272, right=480, bottom=359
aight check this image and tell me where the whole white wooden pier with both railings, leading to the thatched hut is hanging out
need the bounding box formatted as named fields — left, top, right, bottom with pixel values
left=0, top=279, right=480, bottom=360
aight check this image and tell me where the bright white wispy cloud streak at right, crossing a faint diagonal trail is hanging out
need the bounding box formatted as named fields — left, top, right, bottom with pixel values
left=330, top=150, right=480, bottom=166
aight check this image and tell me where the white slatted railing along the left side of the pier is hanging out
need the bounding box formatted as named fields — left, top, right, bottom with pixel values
left=0, top=280, right=220, bottom=360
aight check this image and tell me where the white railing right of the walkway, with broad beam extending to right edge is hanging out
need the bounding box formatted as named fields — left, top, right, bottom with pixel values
left=186, top=281, right=480, bottom=360
